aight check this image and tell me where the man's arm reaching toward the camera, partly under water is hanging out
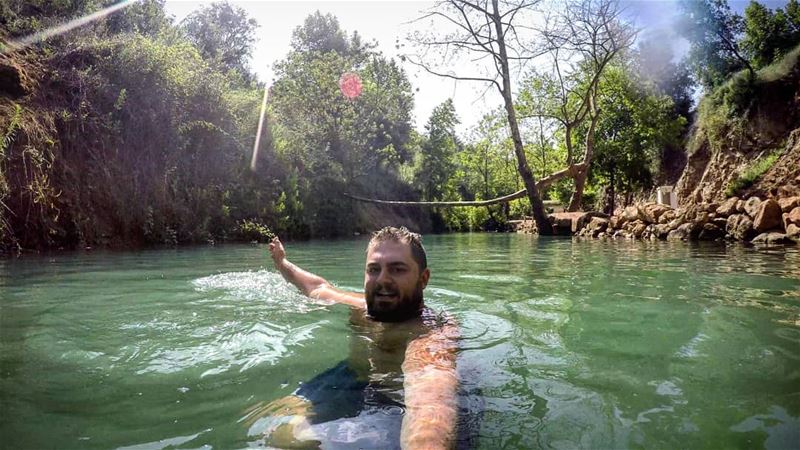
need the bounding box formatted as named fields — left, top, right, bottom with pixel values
left=400, top=323, right=459, bottom=450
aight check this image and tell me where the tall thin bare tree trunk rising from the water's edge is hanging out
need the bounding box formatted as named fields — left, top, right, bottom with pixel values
left=492, top=0, right=553, bottom=235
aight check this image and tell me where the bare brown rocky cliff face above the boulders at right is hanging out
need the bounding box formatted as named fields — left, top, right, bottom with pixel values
left=675, top=53, right=800, bottom=205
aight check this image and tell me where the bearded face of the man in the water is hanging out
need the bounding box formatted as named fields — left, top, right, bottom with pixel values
left=364, top=241, right=430, bottom=322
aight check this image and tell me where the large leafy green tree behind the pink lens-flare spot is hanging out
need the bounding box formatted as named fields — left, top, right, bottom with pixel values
left=270, top=13, right=413, bottom=235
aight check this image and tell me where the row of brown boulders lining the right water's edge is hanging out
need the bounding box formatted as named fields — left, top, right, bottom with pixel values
left=513, top=196, right=800, bottom=245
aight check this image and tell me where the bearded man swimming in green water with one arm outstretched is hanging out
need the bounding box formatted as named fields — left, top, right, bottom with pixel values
left=265, top=227, right=458, bottom=449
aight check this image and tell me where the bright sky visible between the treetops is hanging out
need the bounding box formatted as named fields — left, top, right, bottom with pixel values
left=166, top=0, right=783, bottom=134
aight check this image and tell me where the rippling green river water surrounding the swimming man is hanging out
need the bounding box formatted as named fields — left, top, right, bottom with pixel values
left=0, top=234, right=800, bottom=449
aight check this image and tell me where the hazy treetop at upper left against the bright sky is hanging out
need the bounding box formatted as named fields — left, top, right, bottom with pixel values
left=182, top=0, right=258, bottom=74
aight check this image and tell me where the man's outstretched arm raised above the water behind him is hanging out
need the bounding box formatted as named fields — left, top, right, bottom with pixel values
left=269, top=237, right=366, bottom=308
